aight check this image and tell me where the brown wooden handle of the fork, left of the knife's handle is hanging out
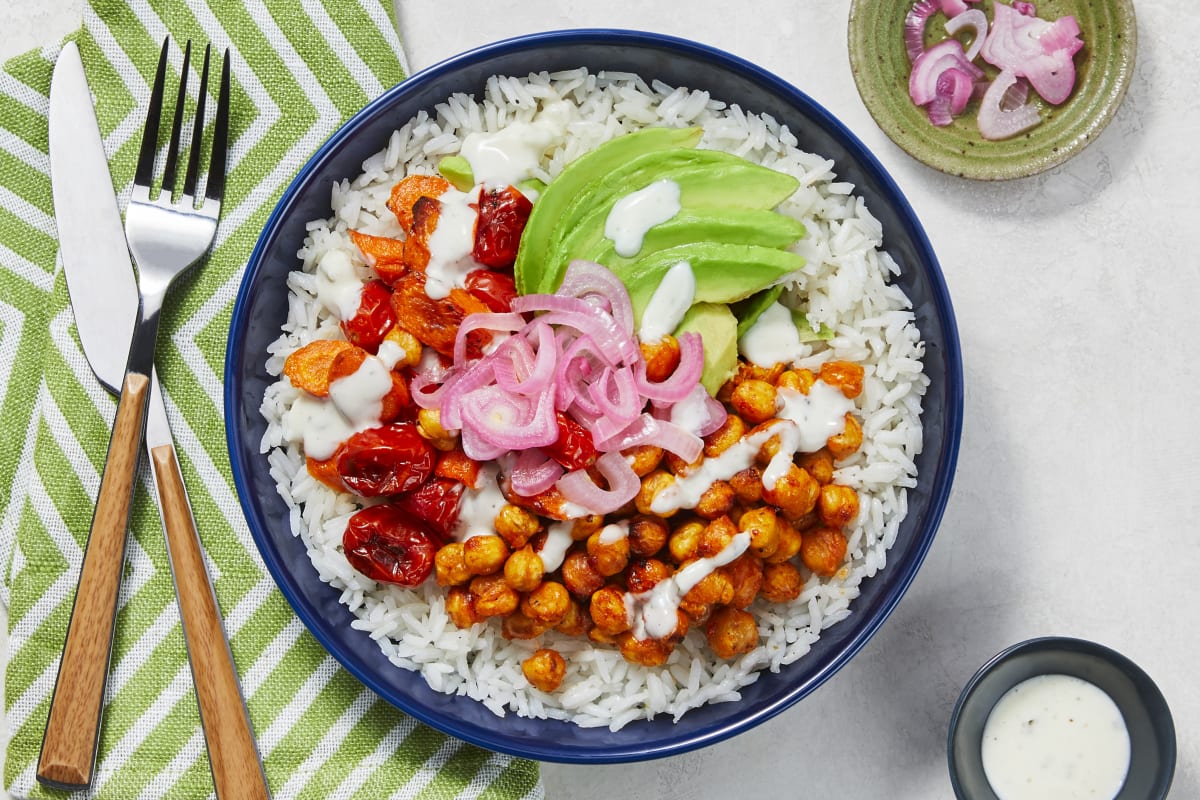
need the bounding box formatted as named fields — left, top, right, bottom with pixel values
left=37, top=373, right=150, bottom=789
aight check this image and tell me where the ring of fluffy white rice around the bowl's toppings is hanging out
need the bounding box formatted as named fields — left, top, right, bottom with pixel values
left=262, top=68, right=928, bottom=730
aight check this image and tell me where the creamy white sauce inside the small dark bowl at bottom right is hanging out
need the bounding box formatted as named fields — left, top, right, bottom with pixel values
left=982, top=675, right=1129, bottom=800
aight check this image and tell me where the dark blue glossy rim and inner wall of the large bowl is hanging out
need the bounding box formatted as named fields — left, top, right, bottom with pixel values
left=224, top=28, right=962, bottom=764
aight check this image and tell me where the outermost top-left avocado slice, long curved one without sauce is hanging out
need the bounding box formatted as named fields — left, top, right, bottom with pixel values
left=512, top=127, right=703, bottom=294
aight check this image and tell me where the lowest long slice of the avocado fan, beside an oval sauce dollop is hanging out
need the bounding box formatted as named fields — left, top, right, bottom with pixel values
left=614, top=241, right=804, bottom=326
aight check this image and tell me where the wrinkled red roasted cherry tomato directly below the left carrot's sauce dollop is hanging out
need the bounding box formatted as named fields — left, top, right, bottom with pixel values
left=337, top=422, right=438, bottom=498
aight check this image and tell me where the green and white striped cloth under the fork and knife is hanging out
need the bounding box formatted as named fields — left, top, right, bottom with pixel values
left=0, top=0, right=544, bottom=800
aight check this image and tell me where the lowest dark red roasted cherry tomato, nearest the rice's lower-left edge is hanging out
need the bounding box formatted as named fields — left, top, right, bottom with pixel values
left=342, top=504, right=438, bottom=587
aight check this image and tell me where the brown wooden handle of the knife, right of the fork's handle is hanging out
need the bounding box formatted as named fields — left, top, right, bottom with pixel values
left=150, top=444, right=270, bottom=800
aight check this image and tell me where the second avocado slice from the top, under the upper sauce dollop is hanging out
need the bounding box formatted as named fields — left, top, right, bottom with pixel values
left=541, top=150, right=803, bottom=291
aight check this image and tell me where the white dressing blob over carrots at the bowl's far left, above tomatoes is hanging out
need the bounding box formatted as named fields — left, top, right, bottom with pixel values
left=282, top=356, right=391, bottom=461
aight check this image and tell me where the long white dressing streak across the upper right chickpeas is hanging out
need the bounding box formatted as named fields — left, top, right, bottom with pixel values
left=650, top=380, right=853, bottom=515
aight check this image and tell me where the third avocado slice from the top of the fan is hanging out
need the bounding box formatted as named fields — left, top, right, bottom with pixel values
left=574, top=209, right=805, bottom=273
